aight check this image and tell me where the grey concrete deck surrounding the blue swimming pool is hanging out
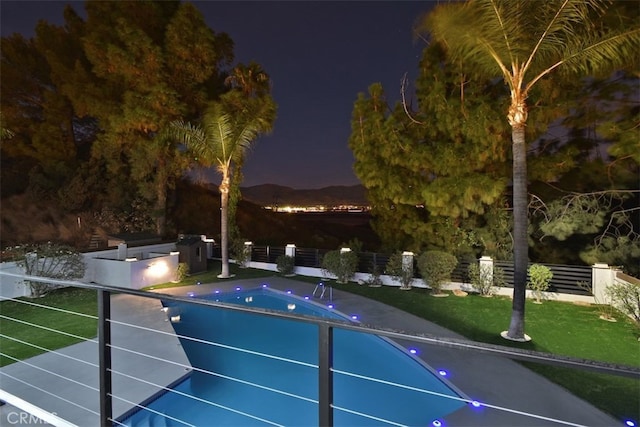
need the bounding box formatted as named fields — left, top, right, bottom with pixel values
left=0, top=276, right=623, bottom=427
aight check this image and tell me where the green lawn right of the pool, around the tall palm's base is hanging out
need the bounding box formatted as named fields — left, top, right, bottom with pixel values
left=335, top=283, right=640, bottom=421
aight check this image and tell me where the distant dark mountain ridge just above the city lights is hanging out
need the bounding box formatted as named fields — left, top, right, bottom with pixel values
left=241, top=184, right=368, bottom=206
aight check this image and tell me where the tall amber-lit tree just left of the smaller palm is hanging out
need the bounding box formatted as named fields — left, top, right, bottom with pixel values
left=58, top=1, right=233, bottom=235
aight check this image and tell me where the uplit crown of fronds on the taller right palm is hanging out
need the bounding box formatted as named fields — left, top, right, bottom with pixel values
left=418, top=0, right=640, bottom=88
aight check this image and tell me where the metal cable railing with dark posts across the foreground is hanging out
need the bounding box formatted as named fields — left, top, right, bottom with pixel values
left=0, top=273, right=640, bottom=426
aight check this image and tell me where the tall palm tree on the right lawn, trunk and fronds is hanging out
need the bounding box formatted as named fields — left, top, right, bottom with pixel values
left=418, top=0, right=640, bottom=341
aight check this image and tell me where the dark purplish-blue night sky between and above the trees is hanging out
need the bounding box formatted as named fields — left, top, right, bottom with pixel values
left=0, top=0, right=434, bottom=188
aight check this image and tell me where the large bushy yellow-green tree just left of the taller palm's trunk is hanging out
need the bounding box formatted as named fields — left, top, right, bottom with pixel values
left=349, top=44, right=510, bottom=255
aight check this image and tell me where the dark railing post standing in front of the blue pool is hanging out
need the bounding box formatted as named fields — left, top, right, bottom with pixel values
left=318, top=323, right=333, bottom=427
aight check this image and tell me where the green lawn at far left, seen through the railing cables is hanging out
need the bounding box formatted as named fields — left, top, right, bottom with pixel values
left=0, top=288, right=98, bottom=366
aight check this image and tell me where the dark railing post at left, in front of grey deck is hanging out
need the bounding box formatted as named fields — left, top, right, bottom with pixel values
left=98, top=289, right=113, bottom=427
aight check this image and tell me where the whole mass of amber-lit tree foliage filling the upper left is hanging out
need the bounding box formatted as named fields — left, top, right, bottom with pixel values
left=0, top=1, right=270, bottom=244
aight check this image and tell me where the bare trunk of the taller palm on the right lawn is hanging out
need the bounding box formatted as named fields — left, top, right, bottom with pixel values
left=506, top=122, right=529, bottom=340
